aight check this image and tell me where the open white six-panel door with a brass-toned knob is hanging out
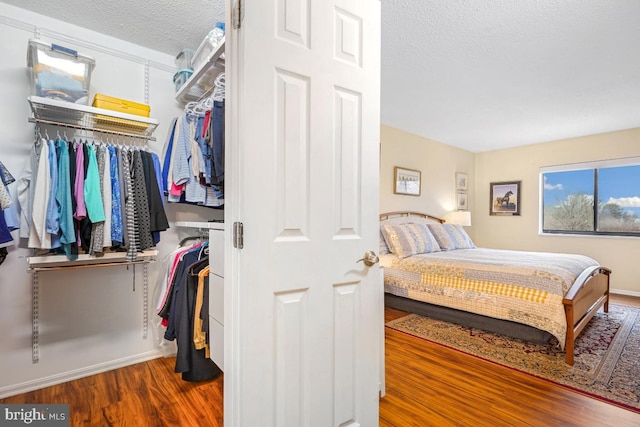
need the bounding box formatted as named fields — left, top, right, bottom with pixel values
left=224, top=0, right=382, bottom=427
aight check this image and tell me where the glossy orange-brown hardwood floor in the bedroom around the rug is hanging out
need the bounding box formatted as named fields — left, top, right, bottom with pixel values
left=380, top=296, right=640, bottom=427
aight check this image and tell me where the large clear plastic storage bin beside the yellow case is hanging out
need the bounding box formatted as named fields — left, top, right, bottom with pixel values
left=27, top=39, right=96, bottom=104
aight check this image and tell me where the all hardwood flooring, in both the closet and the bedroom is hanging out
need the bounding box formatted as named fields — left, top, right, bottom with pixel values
left=0, top=296, right=640, bottom=427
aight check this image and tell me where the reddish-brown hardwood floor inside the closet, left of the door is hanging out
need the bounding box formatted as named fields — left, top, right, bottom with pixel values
left=0, top=357, right=223, bottom=427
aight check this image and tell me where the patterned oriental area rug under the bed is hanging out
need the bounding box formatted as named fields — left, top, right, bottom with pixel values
left=386, top=304, right=640, bottom=413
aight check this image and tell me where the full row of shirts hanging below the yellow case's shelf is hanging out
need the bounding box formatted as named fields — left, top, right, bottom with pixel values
left=18, top=139, right=169, bottom=260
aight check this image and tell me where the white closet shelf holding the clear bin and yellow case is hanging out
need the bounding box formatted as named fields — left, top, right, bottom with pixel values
left=27, top=96, right=158, bottom=141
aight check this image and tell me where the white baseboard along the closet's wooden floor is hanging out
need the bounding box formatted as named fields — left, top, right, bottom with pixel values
left=0, top=350, right=163, bottom=399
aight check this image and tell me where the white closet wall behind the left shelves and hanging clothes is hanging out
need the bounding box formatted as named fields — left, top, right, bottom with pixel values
left=0, top=3, right=222, bottom=397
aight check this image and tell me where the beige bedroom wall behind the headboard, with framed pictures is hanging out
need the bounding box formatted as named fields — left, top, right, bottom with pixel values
left=380, top=126, right=474, bottom=236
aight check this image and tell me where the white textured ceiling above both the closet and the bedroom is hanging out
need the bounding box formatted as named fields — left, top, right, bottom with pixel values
left=1, top=0, right=640, bottom=152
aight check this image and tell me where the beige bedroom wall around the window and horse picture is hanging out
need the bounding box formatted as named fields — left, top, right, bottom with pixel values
left=471, top=128, right=640, bottom=295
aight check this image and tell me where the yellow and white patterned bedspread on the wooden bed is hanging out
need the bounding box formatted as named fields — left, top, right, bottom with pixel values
left=380, top=248, right=598, bottom=346
